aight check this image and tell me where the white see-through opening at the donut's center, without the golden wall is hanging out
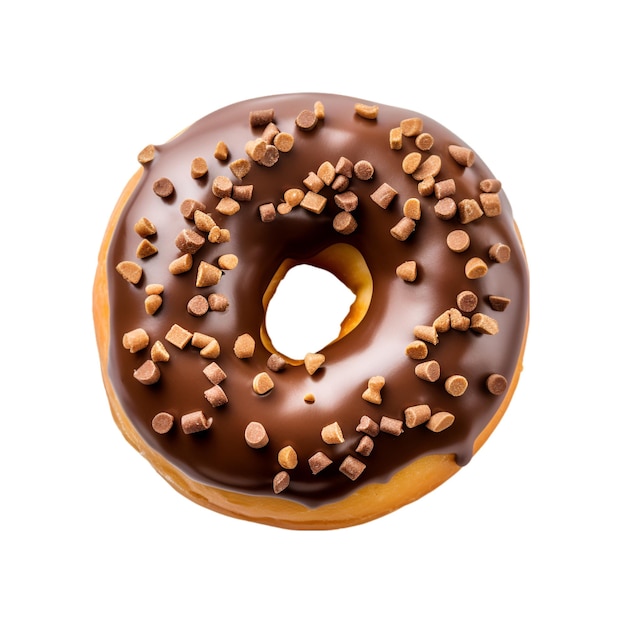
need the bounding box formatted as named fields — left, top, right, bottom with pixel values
left=265, top=264, right=356, bottom=360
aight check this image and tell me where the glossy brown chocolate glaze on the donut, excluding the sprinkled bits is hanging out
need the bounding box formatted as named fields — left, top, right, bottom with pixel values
left=102, top=94, right=528, bottom=506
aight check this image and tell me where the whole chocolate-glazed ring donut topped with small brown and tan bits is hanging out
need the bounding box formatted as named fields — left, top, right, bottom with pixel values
left=93, top=93, right=529, bottom=530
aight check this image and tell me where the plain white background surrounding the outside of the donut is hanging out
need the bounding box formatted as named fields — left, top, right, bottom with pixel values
left=0, top=0, right=626, bottom=625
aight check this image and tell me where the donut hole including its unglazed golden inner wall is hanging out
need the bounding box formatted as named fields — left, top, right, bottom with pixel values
left=261, top=244, right=373, bottom=364
